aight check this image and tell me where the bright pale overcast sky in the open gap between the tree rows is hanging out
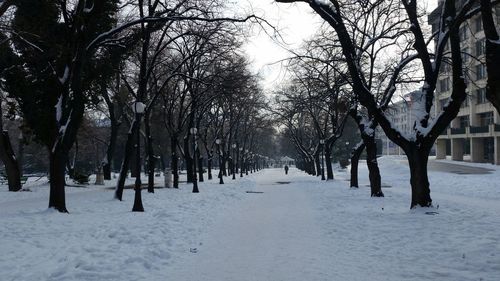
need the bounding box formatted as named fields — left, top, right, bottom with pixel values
left=230, top=0, right=437, bottom=91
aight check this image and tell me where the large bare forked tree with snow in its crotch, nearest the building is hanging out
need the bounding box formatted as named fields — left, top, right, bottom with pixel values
left=277, top=0, right=473, bottom=208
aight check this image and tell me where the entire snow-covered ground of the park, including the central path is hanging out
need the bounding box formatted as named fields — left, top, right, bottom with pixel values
left=0, top=157, right=500, bottom=281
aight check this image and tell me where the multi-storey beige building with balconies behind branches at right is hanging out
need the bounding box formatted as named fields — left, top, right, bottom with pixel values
left=428, top=1, right=500, bottom=165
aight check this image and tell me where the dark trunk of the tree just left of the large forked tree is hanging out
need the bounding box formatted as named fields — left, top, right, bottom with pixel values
left=363, top=135, right=384, bottom=197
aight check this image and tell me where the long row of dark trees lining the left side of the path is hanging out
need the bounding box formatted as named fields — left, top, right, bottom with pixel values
left=0, top=0, right=272, bottom=212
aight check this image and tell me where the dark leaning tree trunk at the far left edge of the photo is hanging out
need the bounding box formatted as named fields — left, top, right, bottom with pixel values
left=0, top=131, right=22, bottom=191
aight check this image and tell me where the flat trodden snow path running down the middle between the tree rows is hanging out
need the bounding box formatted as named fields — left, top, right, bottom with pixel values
left=166, top=169, right=333, bottom=281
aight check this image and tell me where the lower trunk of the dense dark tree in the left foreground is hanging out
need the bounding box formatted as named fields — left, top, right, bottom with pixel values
left=49, top=146, right=68, bottom=213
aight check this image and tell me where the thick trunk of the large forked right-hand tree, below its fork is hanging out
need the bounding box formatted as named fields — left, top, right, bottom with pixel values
left=405, top=143, right=432, bottom=208
